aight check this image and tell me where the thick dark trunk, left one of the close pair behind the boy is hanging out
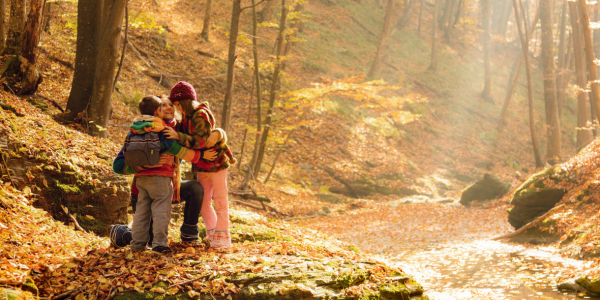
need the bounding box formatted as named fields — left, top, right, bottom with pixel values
left=66, top=0, right=104, bottom=119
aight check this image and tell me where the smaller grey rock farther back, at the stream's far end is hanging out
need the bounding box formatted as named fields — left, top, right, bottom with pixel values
left=460, top=173, right=510, bottom=205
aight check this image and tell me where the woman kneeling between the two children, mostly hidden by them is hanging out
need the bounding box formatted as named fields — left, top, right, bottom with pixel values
left=109, top=97, right=216, bottom=248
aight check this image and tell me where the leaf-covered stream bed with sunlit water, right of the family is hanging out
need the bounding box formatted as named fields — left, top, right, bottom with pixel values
left=300, top=202, right=600, bottom=300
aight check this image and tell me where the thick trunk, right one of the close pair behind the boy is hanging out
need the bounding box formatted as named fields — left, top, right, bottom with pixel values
left=87, top=0, right=127, bottom=137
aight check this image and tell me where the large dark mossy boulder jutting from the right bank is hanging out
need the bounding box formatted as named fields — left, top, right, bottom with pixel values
left=508, top=168, right=567, bottom=229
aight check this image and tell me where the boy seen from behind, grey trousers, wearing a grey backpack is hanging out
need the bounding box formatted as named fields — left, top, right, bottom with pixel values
left=113, top=96, right=210, bottom=254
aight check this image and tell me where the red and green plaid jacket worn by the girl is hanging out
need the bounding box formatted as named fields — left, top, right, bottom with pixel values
left=179, top=102, right=236, bottom=172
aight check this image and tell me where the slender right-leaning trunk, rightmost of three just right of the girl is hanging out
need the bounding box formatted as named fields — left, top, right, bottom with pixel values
left=254, top=0, right=288, bottom=178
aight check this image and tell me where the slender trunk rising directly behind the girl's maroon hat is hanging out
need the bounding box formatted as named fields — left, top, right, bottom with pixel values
left=221, top=0, right=242, bottom=131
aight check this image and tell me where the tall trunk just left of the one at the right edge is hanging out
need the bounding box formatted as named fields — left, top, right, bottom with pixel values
left=568, top=2, right=593, bottom=149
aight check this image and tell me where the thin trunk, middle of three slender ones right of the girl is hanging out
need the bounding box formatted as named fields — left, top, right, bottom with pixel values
left=241, top=0, right=262, bottom=190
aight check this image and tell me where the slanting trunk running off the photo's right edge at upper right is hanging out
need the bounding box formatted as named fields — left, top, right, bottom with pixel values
left=578, top=0, right=600, bottom=124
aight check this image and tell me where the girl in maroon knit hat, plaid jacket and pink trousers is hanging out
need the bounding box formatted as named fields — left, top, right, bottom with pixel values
left=166, top=81, right=236, bottom=248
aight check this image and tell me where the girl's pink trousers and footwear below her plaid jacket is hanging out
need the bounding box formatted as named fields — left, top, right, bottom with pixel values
left=198, top=169, right=231, bottom=248
